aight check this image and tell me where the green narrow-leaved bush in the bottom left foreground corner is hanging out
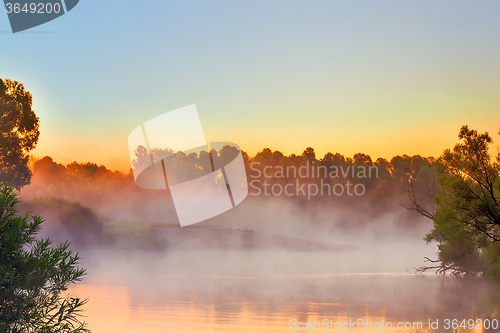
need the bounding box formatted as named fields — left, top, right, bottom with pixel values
left=0, top=184, right=90, bottom=333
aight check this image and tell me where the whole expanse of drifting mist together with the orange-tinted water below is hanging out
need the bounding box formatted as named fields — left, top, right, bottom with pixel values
left=16, top=159, right=500, bottom=333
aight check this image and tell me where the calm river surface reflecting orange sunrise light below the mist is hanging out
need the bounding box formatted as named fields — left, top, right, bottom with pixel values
left=71, top=249, right=500, bottom=333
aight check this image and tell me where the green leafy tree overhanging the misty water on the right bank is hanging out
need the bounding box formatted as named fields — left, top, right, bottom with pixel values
left=413, top=126, right=500, bottom=279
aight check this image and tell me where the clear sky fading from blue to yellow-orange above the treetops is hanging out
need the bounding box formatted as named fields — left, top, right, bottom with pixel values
left=0, top=0, right=500, bottom=171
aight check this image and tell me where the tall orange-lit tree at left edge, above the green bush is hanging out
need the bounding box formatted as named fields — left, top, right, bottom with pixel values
left=0, top=78, right=40, bottom=189
